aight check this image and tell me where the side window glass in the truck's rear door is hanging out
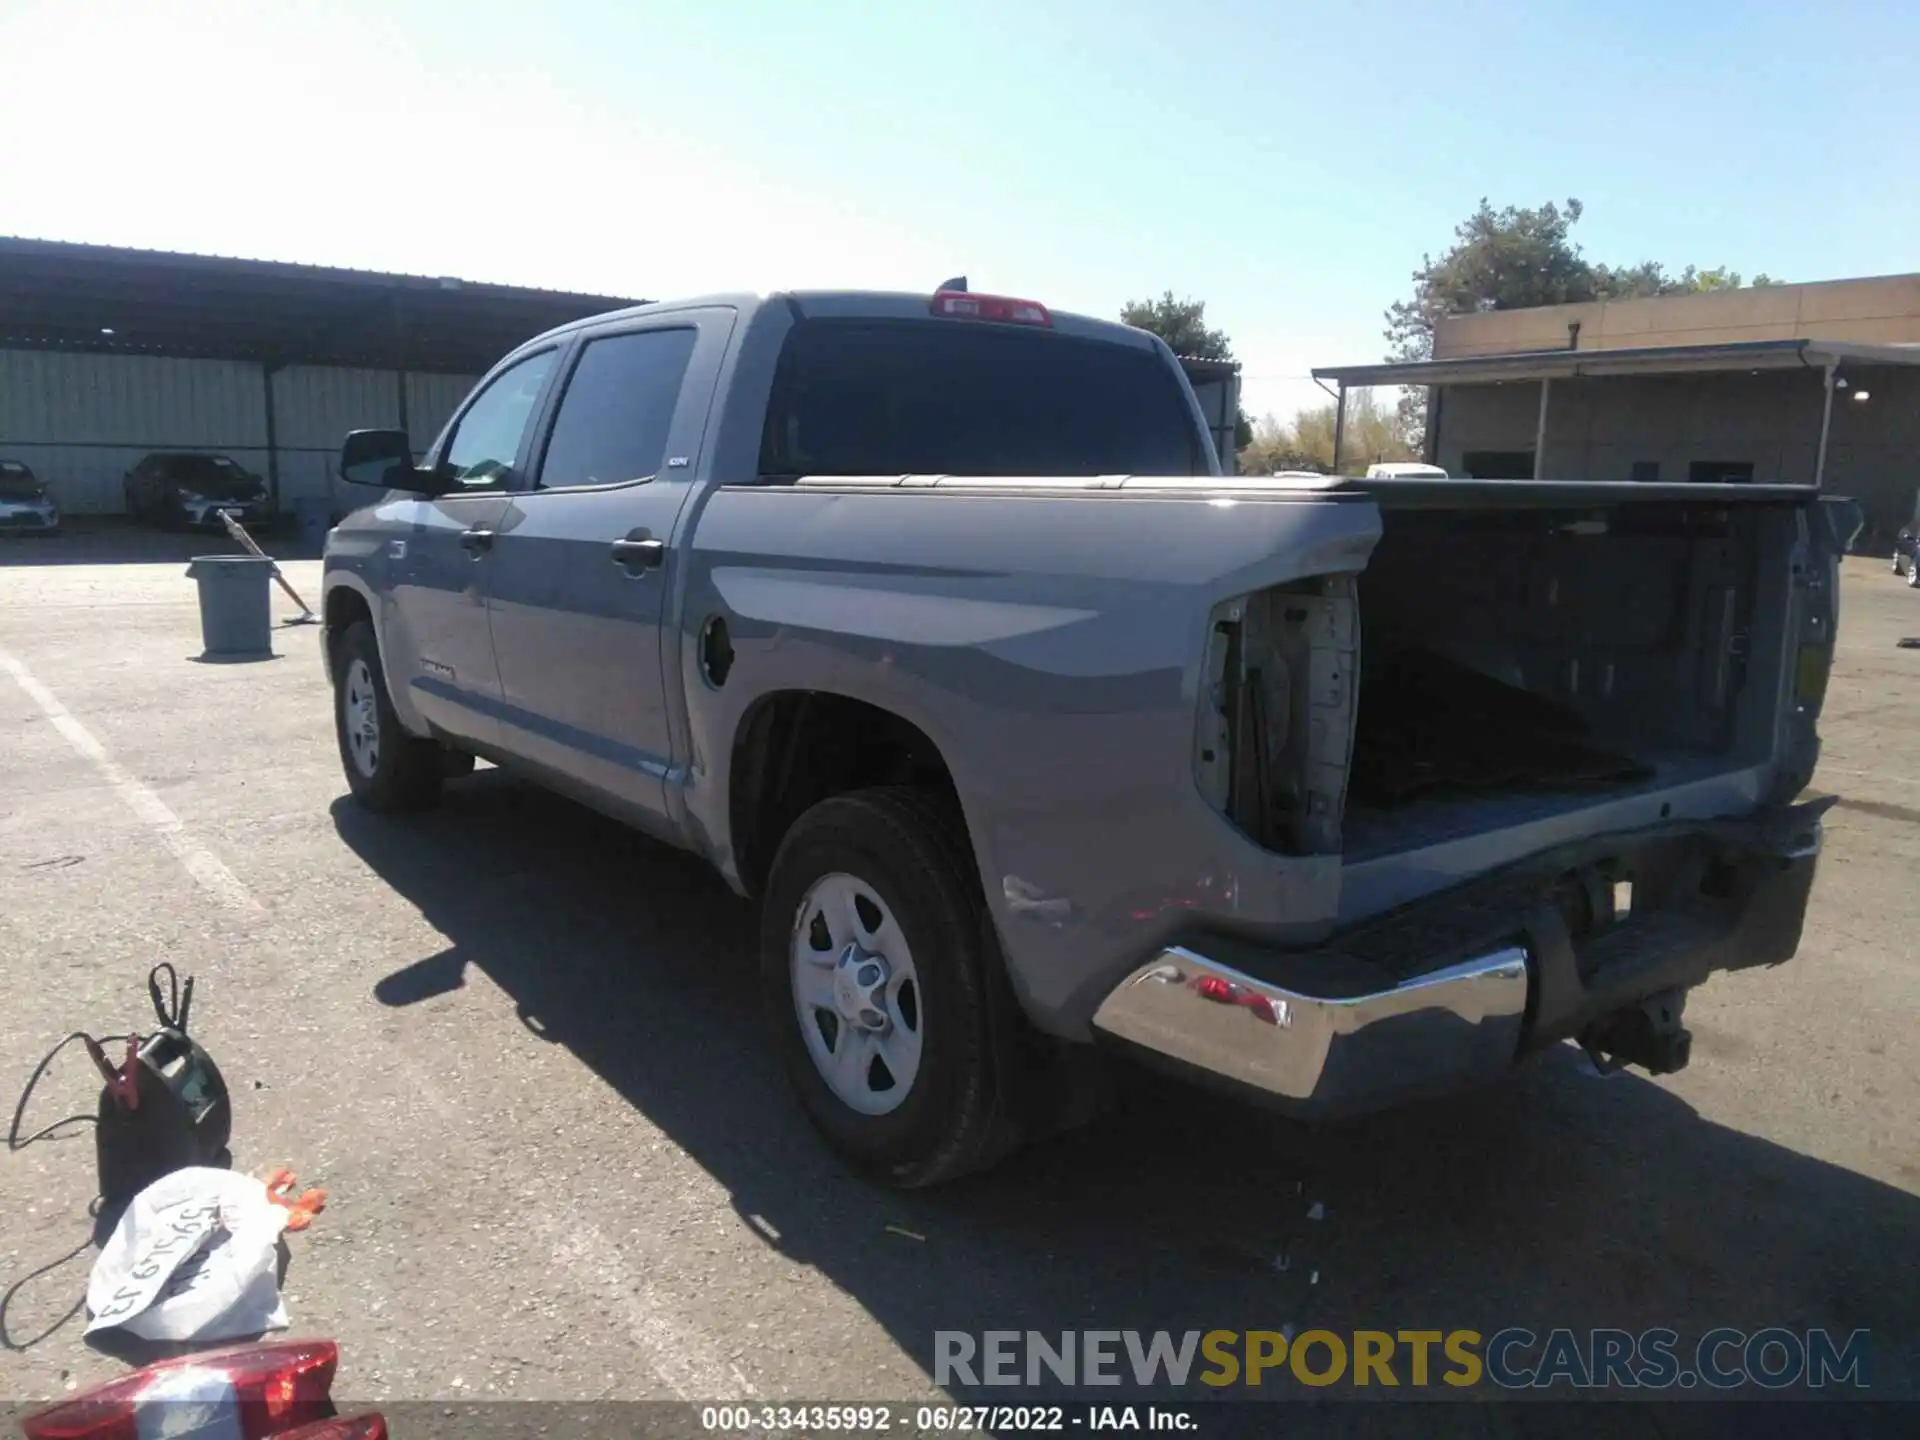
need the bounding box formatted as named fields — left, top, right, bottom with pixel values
left=540, top=328, right=699, bottom=490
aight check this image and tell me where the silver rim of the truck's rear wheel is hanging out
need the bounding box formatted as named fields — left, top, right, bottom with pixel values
left=789, top=874, right=927, bottom=1116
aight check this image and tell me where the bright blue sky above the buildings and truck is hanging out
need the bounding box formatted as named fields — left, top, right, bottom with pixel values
left=0, top=0, right=1920, bottom=413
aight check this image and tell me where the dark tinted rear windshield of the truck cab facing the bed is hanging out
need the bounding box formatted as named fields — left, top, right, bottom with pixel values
left=760, top=321, right=1208, bottom=476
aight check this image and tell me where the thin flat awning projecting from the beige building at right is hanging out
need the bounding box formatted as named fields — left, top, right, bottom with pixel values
left=1313, top=340, right=1920, bottom=386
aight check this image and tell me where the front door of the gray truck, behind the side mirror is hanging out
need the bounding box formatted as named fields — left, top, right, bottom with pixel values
left=380, top=349, right=559, bottom=745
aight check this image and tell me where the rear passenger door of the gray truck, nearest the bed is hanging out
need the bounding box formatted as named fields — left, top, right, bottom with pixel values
left=488, top=307, right=733, bottom=828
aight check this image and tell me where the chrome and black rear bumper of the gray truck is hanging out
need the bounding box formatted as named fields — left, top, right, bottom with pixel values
left=1092, top=803, right=1826, bottom=1119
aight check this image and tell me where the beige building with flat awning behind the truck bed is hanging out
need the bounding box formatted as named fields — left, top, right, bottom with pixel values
left=1315, top=275, right=1920, bottom=532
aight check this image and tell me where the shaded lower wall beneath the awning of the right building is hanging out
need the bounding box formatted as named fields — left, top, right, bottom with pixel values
left=1438, top=367, right=1920, bottom=526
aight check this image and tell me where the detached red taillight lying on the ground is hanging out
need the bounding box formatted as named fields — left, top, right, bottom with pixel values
left=21, top=1340, right=337, bottom=1440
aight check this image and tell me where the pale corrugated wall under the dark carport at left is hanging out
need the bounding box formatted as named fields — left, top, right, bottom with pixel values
left=0, top=349, right=476, bottom=515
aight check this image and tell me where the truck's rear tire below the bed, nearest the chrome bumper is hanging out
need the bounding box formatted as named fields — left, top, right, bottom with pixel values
left=760, top=787, right=1020, bottom=1188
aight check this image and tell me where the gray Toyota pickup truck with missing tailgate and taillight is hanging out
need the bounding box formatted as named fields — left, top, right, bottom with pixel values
left=324, top=290, right=1839, bottom=1185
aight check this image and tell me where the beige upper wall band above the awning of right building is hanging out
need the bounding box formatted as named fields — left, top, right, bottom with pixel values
left=1434, top=275, right=1920, bottom=359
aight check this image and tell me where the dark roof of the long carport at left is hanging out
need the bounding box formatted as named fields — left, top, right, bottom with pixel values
left=0, top=236, right=639, bottom=374
